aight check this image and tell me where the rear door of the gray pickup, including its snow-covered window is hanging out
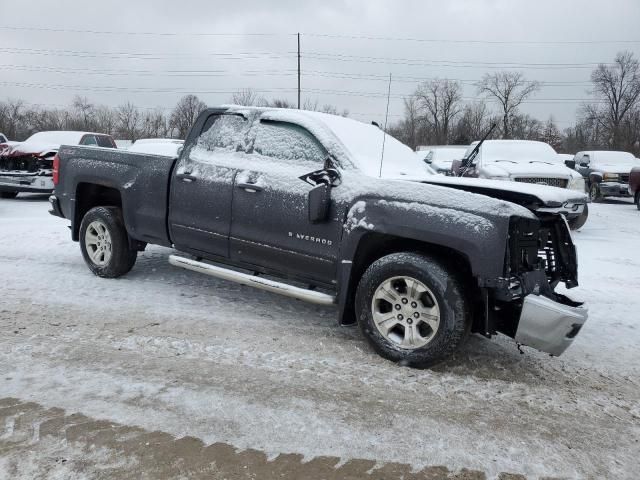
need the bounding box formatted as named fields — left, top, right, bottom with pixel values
left=169, top=113, right=249, bottom=258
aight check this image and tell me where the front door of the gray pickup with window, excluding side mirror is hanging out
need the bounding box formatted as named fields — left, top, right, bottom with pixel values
left=230, top=120, right=344, bottom=283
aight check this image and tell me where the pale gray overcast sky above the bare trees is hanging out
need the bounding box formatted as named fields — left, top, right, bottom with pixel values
left=0, top=0, right=640, bottom=128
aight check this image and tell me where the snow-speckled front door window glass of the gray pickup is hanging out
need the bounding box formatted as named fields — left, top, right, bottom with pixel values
left=253, top=120, right=327, bottom=168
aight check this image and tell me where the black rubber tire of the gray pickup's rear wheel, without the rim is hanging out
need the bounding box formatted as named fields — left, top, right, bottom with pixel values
left=80, top=207, right=138, bottom=278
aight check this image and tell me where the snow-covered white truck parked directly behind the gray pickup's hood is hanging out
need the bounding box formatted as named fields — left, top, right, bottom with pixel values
left=452, top=140, right=589, bottom=230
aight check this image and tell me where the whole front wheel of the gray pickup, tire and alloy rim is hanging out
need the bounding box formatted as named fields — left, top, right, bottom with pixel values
left=355, top=253, right=471, bottom=368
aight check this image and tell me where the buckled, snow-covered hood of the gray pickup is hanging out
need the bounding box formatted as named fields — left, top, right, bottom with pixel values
left=418, top=175, right=587, bottom=207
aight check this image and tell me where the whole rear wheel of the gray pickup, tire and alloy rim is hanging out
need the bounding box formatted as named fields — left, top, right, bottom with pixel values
left=80, top=207, right=138, bottom=278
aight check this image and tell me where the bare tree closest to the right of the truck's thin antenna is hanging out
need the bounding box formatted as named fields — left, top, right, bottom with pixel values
left=415, top=79, right=462, bottom=145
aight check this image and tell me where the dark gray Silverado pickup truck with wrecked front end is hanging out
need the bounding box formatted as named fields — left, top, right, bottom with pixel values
left=50, top=107, right=587, bottom=367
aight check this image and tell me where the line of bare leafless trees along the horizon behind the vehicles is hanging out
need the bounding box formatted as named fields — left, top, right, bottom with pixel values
left=0, top=52, right=640, bottom=155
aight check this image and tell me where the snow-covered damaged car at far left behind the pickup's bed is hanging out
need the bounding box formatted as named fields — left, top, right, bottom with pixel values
left=0, top=131, right=116, bottom=198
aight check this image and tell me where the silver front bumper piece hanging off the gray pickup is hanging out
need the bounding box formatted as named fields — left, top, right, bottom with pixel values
left=514, top=294, right=588, bottom=356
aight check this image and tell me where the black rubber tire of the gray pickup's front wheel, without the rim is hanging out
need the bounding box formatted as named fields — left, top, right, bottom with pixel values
left=355, top=252, right=471, bottom=368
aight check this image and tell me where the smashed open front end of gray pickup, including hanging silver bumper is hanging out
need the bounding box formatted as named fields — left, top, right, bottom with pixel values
left=481, top=216, right=588, bottom=355
